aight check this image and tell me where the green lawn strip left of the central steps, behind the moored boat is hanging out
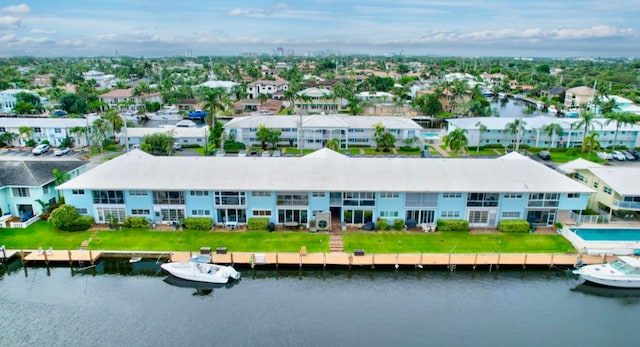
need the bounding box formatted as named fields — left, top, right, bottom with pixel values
left=89, top=229, right=329, bottom=253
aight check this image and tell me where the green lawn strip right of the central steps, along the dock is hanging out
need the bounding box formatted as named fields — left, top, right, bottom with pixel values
left=343, top=232, right=573, bottom=253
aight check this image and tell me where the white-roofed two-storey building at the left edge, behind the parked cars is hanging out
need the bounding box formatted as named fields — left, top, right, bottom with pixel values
left=0, top=117, right=92, bottom=148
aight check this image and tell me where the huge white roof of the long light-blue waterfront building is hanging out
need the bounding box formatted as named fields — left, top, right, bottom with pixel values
left=59, top=149, right=593, bottom=193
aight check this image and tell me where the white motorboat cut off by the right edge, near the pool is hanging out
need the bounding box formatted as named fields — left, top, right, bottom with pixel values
left=573, top=256, right=640, bottom=288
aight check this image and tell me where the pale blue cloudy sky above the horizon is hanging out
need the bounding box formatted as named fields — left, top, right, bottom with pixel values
left=0, top=0, right=640, bottom=57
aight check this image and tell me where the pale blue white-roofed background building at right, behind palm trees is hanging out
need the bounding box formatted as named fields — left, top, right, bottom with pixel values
left=447, top=116, right=640, bottom=148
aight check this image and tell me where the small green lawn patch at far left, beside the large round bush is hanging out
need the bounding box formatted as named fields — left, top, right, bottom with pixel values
left=0, top=222, right=91, bottom=249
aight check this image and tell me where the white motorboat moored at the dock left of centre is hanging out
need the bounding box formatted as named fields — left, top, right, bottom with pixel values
left=160, top=262, right=240, bottom=283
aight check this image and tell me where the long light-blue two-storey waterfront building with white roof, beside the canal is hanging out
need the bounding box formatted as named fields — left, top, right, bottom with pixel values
left=57, top=150, right=592, bottom=228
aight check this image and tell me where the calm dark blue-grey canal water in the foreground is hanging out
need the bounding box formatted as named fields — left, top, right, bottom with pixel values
left=0, top=259, right=640, bottom=346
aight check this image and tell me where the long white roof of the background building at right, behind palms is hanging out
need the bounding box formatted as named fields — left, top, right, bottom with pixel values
left=447, top=116, right=640, bottom=132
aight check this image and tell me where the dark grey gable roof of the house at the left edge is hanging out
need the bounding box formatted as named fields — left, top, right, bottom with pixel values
left=0, top=160, right=88, bottom=187
